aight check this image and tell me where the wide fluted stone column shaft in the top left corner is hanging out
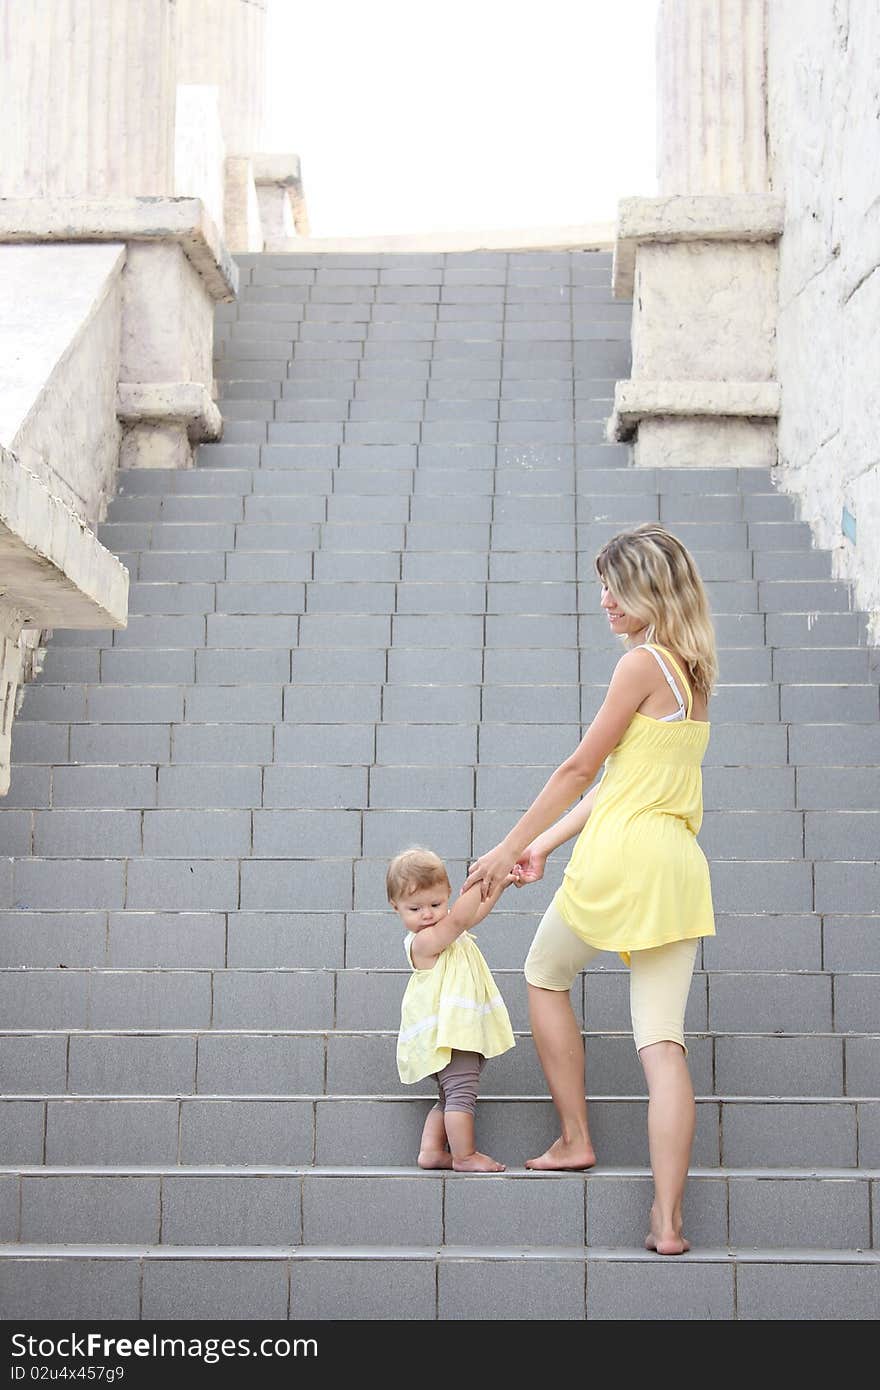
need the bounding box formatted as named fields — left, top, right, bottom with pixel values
left=0, top=0, right=177, bottom=197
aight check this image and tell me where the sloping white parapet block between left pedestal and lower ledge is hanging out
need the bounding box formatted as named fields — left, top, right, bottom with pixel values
left=0, top=243, right=125, bottom=525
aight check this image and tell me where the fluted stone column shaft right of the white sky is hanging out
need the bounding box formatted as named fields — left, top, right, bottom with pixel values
left=658, top=0, right=767, bottom=193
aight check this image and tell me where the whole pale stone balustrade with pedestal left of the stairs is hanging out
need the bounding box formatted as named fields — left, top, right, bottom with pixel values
left=0, top=197, right=238, bottom=791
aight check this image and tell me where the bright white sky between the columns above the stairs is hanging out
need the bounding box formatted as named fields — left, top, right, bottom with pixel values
left=266, top=0, right=658, bottom=236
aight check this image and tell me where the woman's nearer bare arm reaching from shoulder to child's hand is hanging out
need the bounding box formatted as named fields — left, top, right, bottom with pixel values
left=464, top=648, right=655, bottom=897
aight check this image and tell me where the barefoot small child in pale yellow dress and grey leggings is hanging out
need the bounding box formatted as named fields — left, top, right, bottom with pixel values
left=385, top=847, right=514, bottom=1173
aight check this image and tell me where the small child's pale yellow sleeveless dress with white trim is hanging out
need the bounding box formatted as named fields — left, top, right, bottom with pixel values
left=398, top=931, right=514, bottom=1083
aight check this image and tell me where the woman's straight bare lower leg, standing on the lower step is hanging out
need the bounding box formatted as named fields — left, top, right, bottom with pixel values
left=638, top=1043, right=696, bottom=1255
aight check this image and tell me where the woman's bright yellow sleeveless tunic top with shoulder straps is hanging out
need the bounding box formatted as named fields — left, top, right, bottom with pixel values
left=555, top=644, right=715, bottom=965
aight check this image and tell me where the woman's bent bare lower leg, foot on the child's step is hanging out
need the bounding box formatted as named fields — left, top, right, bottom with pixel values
left=525, top=984, right=596, bottom=1169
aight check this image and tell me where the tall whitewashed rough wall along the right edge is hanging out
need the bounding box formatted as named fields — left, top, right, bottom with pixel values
left=767, top=0, right=880, bottom=635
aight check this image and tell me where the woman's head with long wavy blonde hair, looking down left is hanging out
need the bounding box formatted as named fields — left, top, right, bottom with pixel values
left=596, top=521, right=717, bottom=699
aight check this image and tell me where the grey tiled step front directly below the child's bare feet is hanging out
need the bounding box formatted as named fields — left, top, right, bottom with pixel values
left=0, top=1166, right=880, bottom=1257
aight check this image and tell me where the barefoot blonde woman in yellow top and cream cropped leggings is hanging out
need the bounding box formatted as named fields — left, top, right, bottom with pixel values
left=463, top=523, right=717, bottom=1255
